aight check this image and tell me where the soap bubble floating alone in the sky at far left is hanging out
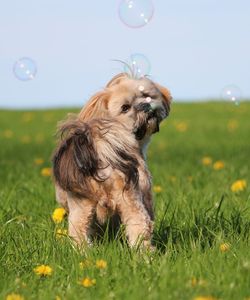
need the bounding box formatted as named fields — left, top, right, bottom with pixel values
left=13, top=57, right=37, bottom=81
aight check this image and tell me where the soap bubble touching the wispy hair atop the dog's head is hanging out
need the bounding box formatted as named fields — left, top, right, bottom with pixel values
left=124, top=53, right=151, bottom=78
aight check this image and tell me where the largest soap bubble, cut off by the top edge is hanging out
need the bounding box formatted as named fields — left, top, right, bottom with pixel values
left=119, top=0, right=154, bottom=28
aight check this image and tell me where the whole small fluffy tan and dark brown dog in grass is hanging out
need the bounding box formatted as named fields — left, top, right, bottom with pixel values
left=53, top=73, right=171, bottom=247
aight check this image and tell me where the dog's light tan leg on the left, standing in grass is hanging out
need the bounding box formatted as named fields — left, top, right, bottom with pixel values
left=68, top=195, right=96, bottom=245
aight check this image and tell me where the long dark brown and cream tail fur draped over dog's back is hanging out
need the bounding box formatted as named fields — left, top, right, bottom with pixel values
left=53, top=119, right=138, bottom=199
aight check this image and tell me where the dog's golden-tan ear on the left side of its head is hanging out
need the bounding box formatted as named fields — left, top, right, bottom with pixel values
left=78, top=91, right=109, bottom=122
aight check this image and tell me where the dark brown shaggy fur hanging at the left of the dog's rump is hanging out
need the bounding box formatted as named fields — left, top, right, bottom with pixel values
left=52, top=123, right=98, bottom=194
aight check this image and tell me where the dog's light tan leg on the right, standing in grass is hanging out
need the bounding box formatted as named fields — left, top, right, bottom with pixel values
left=117, top=191, right=153, bottom=248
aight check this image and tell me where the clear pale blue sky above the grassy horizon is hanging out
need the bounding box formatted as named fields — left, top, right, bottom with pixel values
left=0, top=0, right=250, bottom=108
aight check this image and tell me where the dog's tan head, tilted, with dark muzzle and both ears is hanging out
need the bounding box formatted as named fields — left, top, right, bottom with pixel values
left=79, top=73, right=171, bottom=141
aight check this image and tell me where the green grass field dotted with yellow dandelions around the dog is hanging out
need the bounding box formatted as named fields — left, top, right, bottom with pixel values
left=0, top=102, right=250, bottom=300
